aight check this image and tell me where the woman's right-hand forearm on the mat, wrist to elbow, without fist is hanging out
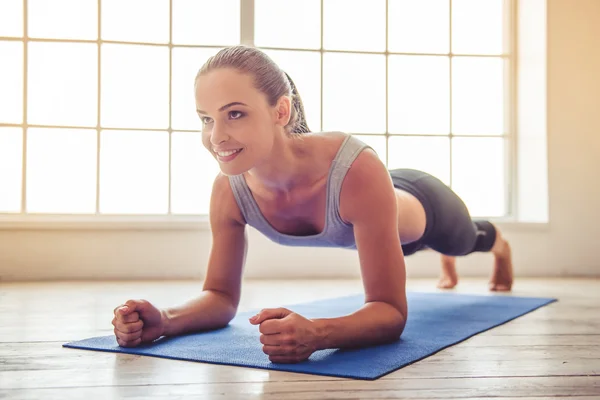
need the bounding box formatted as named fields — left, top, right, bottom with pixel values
left=313, top=302, right=406, bottom=350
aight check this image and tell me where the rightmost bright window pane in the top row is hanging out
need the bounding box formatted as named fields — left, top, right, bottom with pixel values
left=452, top=0, right=504, bottom=54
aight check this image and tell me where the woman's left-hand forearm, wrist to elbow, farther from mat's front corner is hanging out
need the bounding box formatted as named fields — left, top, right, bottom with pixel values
left=162, top=290, right=236, bottom=336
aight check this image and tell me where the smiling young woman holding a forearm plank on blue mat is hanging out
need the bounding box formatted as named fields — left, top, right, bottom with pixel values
left=113, top=46, right=512, bottom=362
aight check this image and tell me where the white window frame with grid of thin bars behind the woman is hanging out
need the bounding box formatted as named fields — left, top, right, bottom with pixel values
left=0, top=0, right=534, bottom=229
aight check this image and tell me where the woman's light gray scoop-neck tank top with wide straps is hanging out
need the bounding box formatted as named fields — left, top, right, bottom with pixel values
left=229, top=135, right=371, bottom=249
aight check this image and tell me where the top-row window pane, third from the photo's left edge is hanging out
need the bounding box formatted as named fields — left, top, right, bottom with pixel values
left=101, top=0, right=169, bottom=43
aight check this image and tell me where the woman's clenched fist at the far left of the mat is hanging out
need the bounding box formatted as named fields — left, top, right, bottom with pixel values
left=112, top=300, right=165, bottom=347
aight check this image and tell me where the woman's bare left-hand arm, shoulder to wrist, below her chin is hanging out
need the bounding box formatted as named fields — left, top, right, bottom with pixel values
left=162, top=175, right=247, bottom=336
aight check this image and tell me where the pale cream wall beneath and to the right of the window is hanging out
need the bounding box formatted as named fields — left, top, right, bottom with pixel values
left=0, top=0, right=600, bottom=280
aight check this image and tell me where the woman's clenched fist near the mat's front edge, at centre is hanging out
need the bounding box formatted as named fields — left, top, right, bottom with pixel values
left=250, top=308, right=318, bottom=363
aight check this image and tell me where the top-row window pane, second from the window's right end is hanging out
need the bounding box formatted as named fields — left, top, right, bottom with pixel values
left=388, top=0, right=450, bottom=53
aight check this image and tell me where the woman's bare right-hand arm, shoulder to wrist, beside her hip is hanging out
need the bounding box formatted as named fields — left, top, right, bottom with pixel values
left=313, top=150, right=408, bottom=349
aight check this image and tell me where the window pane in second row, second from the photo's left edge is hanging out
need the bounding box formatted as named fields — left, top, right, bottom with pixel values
left=27, top=42, right=98, bottom=126
